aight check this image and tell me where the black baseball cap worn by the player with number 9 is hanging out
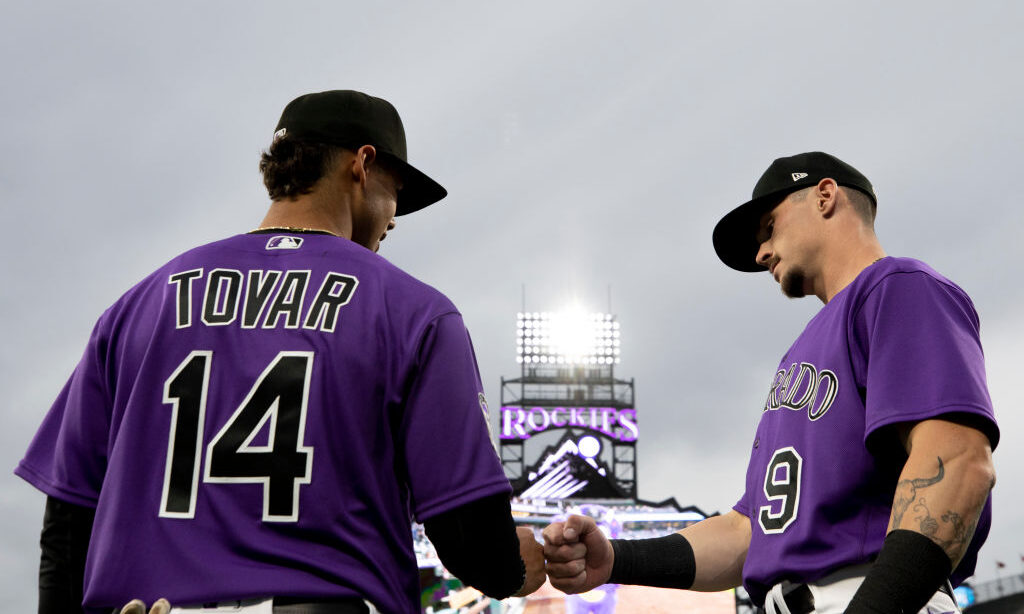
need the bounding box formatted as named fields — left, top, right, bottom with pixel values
left=712, top=151, right=878, bottom=273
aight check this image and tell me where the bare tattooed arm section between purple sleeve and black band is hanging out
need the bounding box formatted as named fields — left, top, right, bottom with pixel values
left=889, top=420, right=995, bottom=567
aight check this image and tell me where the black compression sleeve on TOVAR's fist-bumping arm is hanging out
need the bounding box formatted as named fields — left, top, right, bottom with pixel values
left=423, top=494, right=526, bottom=599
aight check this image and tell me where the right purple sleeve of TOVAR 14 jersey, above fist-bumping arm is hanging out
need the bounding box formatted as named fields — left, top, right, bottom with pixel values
left=398, top=313, right=512, bottom=522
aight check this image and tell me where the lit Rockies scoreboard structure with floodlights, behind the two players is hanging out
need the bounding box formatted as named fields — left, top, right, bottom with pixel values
left=413, top=311, right=742, bottom=614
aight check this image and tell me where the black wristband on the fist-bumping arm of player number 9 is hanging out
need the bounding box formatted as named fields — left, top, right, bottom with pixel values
left=608, top=533, right=696, bottom=588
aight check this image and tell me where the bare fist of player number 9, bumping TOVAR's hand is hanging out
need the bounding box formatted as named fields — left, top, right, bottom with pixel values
left=543, top=516, right=615, bottom=595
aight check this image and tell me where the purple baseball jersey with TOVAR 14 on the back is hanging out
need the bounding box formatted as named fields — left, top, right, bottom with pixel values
left=15, top=233, right=511, bottom=613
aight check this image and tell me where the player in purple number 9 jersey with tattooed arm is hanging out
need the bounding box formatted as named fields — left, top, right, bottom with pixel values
left=544, top=151, right=999, bottom=614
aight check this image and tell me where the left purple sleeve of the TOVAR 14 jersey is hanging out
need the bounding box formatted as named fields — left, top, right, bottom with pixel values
left=14, top=318, right=111, bottom=508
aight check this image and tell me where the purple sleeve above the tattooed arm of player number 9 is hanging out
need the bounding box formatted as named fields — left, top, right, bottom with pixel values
left=854, top=271, right=999, bottom=448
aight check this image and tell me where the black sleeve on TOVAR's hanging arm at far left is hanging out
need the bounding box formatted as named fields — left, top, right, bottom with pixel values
left=39, top=496, right=95, bottom=614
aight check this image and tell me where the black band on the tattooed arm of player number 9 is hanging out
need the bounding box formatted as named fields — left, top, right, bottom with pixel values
left=846, top=529, right=952, bottom=614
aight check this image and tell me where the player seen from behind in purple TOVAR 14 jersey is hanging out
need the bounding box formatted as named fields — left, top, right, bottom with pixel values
left=15, top=91, right=544, bottom=614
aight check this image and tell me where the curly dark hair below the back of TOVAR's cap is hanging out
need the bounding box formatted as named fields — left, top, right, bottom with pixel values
left=259, top=138, right=343, bottom=201
